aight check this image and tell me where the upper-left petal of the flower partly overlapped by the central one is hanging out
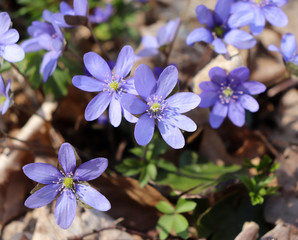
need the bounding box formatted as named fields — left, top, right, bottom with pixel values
left=84, top=52, right=112, bottom=81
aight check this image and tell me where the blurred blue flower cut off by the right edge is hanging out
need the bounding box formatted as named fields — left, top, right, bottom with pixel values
left=268, top=33, right=298, bottom=65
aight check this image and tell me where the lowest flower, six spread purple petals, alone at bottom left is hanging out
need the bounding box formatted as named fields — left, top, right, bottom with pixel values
left=23, top=143, right=111, bottom=229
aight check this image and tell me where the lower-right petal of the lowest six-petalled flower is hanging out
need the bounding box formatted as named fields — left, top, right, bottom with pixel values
left=76, top=184, right=111, bottom=211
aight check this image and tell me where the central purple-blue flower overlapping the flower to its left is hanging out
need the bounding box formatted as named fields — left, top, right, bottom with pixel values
left=122, top=64, right=200, bottom=149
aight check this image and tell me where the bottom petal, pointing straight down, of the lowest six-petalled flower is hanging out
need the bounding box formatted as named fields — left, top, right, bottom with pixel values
left=55, top=189, right=77, bottom=229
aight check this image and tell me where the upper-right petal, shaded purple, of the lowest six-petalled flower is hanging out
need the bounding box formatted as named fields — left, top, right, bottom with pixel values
left=74, top=158, right=108, bottom=181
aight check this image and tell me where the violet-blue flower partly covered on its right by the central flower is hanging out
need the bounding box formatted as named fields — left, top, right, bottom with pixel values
left=72, top=46, right=137, bottom=127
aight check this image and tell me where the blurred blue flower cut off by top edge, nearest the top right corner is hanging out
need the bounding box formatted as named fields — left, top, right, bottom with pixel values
left=228, top=0, right=288, bottom=35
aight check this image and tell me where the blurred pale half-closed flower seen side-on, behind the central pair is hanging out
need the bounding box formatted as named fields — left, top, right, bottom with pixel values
left=137, top=18, right=180, bottom=57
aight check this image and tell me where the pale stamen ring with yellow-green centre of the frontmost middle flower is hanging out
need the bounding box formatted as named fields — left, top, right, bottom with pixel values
left=146, top=95, right=168, bottom=121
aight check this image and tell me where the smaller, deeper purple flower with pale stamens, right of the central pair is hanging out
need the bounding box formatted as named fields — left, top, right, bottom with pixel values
left=199, top=67, right=266, bottom=128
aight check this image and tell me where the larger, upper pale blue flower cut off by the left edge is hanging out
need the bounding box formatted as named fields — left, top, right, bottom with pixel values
left=0, top=12, right=25, bottom=62
